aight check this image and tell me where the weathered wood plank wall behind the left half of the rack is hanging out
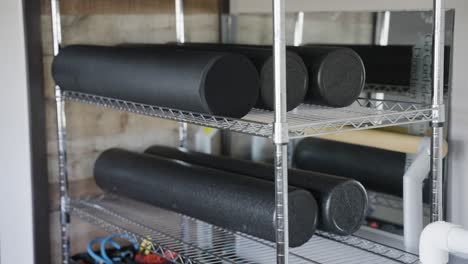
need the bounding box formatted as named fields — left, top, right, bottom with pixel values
left=41, top=0, right=218, bottom=263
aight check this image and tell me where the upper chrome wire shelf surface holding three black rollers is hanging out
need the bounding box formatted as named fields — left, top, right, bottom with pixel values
left=64, top=91, right=432, bottom=138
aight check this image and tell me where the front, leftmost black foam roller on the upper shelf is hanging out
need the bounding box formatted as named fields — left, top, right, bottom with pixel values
left=52, top=45, right=259, bottom=118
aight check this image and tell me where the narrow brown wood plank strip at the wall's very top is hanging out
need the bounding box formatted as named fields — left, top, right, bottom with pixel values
left=41, top=0, right=219, bottom=15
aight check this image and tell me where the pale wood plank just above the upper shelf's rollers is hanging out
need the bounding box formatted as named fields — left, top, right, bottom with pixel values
left=41, top=14, right=218, bottom=56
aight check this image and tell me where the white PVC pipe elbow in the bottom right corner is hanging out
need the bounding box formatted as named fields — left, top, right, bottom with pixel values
left=419, top=221, right=468, bottom=264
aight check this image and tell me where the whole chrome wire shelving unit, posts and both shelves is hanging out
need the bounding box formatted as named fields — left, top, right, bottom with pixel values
left=51, top=0, right=445, bottom=264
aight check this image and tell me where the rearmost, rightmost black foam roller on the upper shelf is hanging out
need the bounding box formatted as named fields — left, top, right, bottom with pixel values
left=289, top=46, right=366, bottom=107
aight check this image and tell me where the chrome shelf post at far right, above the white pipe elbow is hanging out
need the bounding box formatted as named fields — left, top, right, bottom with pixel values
left=431, top=0, right=445, bottom=222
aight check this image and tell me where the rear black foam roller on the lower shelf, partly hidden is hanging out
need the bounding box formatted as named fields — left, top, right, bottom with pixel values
left=146, top=146, right=367, bottom=235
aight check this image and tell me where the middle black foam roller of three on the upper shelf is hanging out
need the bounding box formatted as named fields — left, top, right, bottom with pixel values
left=132, top=43, right=309, bottom=111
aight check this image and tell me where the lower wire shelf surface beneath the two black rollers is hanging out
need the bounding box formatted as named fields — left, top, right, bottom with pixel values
left=71, top=194, right=419, bottom=264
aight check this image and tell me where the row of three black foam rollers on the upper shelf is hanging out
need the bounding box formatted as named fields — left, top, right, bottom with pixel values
left=52, top=43, right=365, bottom=118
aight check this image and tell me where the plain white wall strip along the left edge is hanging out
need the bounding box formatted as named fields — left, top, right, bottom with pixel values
left=0, top=0, right=34, bottom=263
